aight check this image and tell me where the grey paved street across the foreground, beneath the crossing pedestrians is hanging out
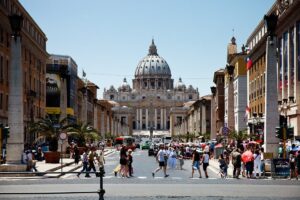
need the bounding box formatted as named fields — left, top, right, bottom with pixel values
left=0, top=150, right=300, bottom=200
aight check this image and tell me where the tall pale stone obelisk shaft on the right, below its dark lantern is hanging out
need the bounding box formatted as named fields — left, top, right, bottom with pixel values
left=264, top=36, right=279, bottom=157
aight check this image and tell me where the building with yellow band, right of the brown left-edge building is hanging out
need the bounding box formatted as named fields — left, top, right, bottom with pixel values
left=46, top=54, right=78, bottom=122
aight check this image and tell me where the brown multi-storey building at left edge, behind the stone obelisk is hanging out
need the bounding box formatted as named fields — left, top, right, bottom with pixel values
left=0, top=0, right=48, bottom=143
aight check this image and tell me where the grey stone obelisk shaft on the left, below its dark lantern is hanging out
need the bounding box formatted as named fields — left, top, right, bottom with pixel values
left=6, top=36, right=24, bottom=164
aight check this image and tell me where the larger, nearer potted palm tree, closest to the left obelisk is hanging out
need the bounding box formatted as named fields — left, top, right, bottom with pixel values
left=29, top=115, right=68, bottom=151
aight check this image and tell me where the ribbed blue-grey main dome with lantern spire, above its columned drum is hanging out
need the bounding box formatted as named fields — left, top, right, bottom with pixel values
left=135, top=39, right=171, bottom=78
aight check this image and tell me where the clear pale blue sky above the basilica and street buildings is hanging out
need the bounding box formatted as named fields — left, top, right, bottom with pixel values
left=20, top=0, right=275, bottom=98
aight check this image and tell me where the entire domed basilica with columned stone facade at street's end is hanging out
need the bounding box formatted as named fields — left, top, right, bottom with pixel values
left=103, top=40, right=199, bottom=135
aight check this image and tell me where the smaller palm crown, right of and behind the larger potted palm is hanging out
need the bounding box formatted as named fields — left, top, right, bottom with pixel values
left=67, top=122, right=100, bottom=146
